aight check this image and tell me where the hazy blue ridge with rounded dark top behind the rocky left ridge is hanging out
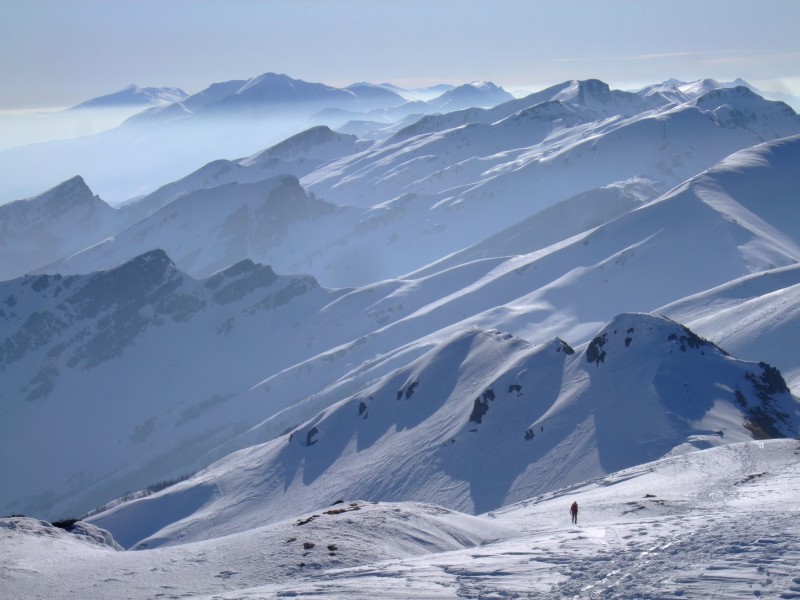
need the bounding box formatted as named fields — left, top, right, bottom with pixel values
left=46, top=172, right=362, bottom=277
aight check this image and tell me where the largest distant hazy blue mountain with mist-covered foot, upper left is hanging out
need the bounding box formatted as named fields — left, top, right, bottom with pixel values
left=0, top=73, right=404, bottom=205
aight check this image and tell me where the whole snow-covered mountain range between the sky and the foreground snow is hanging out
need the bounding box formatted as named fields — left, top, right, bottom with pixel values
left=0, top=74, right=800, bottom=596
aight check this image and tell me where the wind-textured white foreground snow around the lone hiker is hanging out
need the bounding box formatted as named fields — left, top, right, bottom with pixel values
left=0, top=440, right=800, bottom=600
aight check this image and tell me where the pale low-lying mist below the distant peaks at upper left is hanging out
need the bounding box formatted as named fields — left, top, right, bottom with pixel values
left=0, top=109, right=324, bottom=205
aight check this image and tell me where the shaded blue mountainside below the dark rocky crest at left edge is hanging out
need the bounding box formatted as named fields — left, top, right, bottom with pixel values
left=0, top=250, right=354, bottom=518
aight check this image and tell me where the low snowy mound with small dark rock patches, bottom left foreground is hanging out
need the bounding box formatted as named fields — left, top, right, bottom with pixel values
left=0, top=501, right=516, bottom=600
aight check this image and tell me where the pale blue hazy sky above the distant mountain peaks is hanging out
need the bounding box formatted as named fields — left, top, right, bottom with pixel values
left=0, top=0, right=800, bottom=110
